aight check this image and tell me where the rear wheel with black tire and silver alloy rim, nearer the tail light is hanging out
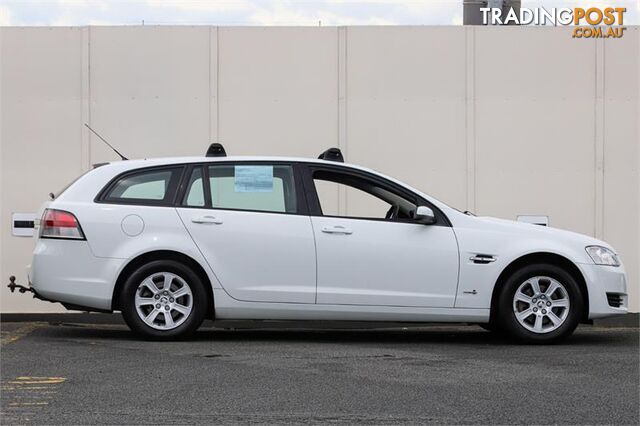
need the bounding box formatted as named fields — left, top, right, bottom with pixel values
left=120, top=260, right=208, bottom=340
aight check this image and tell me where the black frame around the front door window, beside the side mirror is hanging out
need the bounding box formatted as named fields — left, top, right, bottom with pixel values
left=302, top=163, right=451, bottom=227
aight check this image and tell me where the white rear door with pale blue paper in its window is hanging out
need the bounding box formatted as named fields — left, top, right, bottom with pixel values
left=177, top=162, right=316, bottom=303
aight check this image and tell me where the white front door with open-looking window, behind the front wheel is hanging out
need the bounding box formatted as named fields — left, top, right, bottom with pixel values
left=306, top=166, right=458, bottom=308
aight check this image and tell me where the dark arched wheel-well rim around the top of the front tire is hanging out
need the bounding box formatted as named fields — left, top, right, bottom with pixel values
left=490, top=252, right=589, bottom=322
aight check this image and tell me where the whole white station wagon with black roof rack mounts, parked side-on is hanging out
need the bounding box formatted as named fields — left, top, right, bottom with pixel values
left=11, top=144, right=628, bottom=342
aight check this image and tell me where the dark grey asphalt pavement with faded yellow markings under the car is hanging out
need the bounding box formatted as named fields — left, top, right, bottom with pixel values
left=0, top=322, right=640, bottom=425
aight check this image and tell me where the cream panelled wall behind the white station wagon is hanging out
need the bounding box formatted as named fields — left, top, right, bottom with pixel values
left=0, top=26, right=640, bottom=312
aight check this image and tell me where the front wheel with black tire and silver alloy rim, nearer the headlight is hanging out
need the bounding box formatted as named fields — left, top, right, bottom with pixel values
left=496, top=263, right=584, bottom=344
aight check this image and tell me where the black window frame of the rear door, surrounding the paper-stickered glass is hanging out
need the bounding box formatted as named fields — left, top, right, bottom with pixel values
left=176, top=160, right=309, bottom=216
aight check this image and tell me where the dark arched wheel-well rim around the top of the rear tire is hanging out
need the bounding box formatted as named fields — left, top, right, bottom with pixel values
left=111, top=250, right=215, bottom=319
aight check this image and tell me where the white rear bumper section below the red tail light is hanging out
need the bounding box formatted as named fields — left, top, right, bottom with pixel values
left=29, top=238, right=124, bottom=310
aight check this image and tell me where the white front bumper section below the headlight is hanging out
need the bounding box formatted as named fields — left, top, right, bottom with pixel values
left=578, top=263, right=629, bottom=319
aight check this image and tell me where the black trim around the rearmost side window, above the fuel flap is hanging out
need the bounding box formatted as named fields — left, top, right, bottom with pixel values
left=93, top=164, right=186, bottom=207
